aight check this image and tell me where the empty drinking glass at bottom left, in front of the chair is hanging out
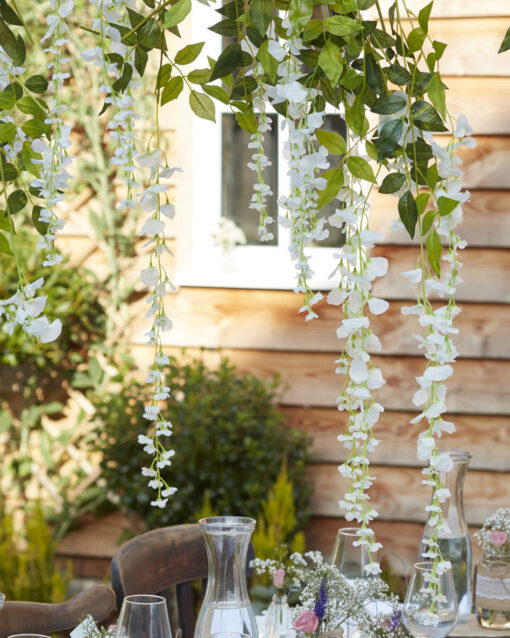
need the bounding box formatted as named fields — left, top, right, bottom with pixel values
left=115, top=594, right=172, bottom=638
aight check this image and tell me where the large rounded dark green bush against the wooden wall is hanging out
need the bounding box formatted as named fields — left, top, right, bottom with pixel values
left=94, top=359, right=309, bottom=529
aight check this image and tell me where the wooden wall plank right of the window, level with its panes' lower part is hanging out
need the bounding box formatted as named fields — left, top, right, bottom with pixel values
left=370, top=189, right=510, bottom=248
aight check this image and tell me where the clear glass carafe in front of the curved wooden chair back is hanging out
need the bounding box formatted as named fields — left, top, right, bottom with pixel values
left=194, top=516, right=258, bottom=638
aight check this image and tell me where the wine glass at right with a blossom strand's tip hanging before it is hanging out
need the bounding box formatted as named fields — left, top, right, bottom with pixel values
left=402, top=562, right=458, bottom=638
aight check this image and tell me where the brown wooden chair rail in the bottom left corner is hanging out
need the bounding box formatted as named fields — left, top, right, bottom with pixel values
left=0, top=585, right=115, bottom=638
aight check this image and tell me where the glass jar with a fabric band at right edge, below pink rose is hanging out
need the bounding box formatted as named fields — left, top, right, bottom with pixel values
left=475, top=554, right=510, bottom=629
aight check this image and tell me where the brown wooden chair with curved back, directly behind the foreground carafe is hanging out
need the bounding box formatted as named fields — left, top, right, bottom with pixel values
left=111, top=525, right=255, bottom=638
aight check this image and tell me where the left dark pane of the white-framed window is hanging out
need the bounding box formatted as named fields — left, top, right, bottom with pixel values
left=221, top=113, right=278, bottom=246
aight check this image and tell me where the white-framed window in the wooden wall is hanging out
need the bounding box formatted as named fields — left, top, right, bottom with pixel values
left=173, top=4, right=345, bottom=289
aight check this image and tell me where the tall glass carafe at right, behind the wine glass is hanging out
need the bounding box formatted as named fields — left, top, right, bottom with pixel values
left=418, top=450, right=472, bottom=622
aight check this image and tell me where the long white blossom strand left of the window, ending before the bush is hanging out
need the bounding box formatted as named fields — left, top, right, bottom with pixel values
left=136, top=148, right=181, bottom=508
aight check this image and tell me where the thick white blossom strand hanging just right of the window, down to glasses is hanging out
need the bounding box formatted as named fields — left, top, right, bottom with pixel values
left=328, top=180, right=389, bottom=574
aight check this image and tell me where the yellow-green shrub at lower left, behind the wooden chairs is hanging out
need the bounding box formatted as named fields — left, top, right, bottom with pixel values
left=0, top=501, right=71, bottom=603
